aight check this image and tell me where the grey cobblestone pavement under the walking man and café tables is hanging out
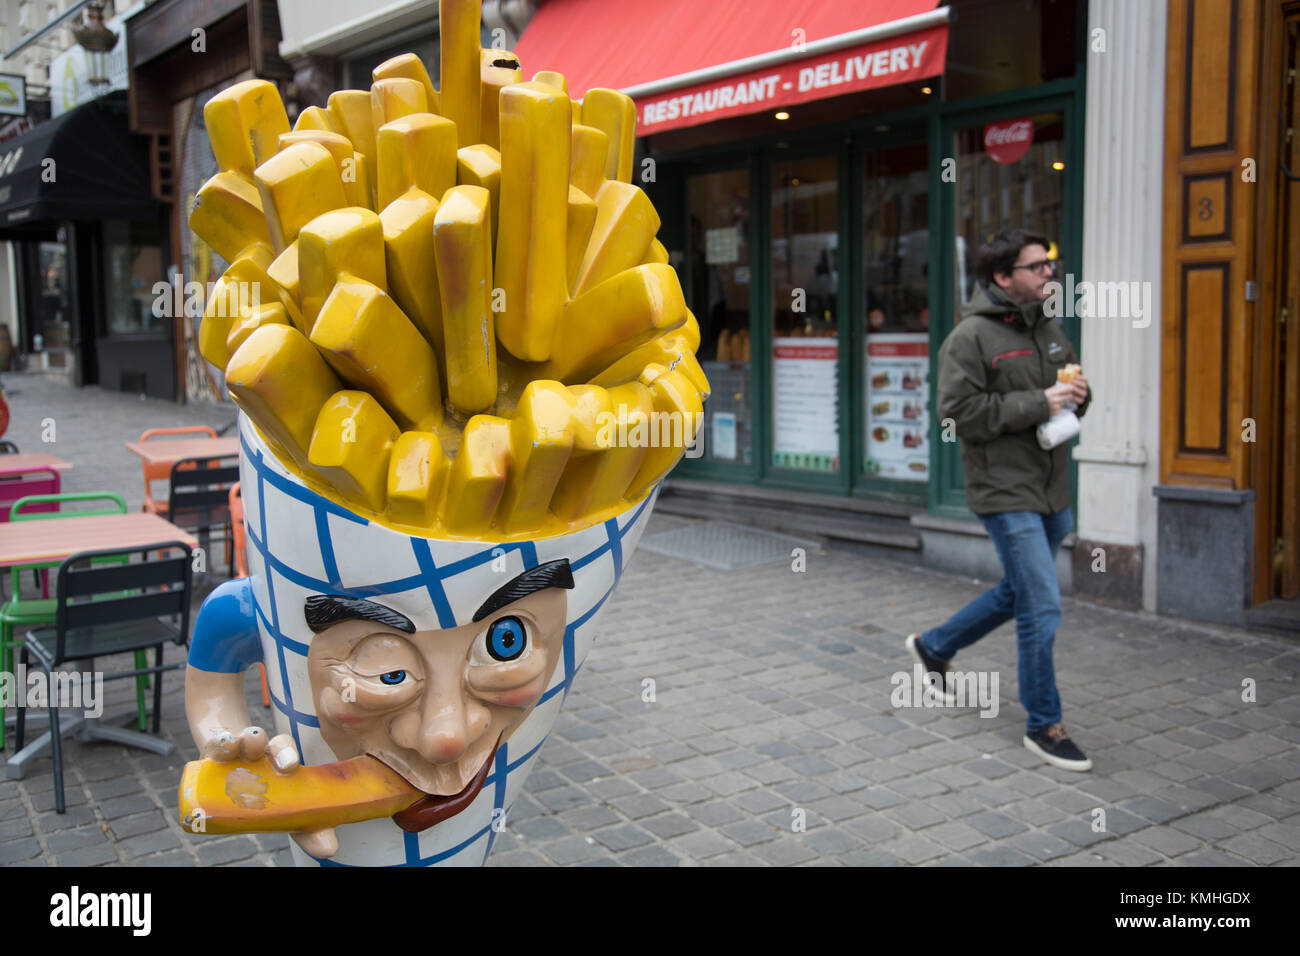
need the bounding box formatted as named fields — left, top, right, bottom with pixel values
left=0, top=376, right=1300, bottom=866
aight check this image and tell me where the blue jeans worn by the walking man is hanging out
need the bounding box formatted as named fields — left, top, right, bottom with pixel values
left=920, top=509, right=1074, bottom=731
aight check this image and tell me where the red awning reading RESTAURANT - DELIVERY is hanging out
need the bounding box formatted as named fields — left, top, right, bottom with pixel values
left=515, top=0, right=948, bottom=135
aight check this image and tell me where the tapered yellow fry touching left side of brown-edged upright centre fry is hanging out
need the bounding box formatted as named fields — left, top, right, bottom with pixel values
left=380, top=187, right=446, bottom=356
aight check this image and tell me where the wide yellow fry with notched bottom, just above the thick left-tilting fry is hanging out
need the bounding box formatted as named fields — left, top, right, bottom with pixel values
left=298, top=206, right=387, bottom=334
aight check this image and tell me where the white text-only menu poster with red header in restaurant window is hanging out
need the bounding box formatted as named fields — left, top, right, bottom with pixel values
left=772, top=337, right=840, bottom=475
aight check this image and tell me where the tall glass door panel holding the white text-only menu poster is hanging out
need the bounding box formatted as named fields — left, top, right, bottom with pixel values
left=768, top=155, right=841, bottom=484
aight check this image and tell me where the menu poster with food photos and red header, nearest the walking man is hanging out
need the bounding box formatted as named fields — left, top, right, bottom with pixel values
left=863, top=333, right=930, bottom=481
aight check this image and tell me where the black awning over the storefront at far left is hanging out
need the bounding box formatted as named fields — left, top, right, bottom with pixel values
left=0, top=91, right=159, bottom=239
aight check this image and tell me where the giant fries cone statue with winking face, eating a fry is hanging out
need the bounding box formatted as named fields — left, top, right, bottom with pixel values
left=179, top=0, right=709, bottom=866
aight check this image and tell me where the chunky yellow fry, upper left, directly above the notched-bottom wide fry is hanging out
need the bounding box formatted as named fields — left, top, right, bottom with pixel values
left=254, top=143, right=347, bottom=252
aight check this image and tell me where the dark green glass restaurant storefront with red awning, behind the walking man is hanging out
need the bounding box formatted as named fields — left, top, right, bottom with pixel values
left=516, top=0, right=1097, bottom=582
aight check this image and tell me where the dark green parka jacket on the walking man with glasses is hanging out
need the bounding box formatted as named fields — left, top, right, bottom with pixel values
left=937, top=285, right=1092, bottom=515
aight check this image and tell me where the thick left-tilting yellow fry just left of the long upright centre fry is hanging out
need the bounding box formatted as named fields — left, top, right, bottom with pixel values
left=311, top=273, right=442, bottom=432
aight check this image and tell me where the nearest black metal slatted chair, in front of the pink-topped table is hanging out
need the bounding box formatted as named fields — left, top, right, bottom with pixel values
left=16, top=541, right=192, bottom=813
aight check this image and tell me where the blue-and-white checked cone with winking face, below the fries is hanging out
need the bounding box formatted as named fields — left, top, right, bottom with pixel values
left=191, top=416, right=655, bottom=866
